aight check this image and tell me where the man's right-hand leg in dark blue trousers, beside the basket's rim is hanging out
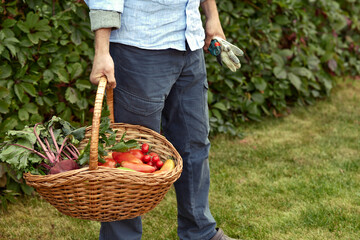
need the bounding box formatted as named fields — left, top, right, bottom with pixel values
left=162, top=47, right=216, bottom=240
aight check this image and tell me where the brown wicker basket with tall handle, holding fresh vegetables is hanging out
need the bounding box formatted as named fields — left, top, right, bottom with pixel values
left=24, top=78, right=182, bottom=222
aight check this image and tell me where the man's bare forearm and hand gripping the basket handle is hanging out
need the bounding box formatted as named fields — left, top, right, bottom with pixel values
left=90, top=28, right=116, bottom=88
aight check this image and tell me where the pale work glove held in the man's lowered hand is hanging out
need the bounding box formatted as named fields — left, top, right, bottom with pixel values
left=214, top=37, right=244, bottom=72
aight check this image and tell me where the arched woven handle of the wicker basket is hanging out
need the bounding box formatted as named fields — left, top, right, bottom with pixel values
left=89, top=76, right=114, bottom=170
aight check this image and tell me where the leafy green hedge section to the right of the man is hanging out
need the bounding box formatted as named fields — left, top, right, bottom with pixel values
left=207, top=0, right=360, bottom=134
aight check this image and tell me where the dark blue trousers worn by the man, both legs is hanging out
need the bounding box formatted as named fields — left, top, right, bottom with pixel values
left=100, top=43, right=216, bottom=240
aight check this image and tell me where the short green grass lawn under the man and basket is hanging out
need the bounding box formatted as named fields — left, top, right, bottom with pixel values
left=0, top=80, right=360, bottom=240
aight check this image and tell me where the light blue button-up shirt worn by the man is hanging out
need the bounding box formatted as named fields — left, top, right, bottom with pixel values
left=86, top=0, right=205, bottom=51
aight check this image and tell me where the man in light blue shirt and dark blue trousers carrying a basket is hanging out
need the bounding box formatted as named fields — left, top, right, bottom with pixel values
left=87, top=0, right=240, bottom=240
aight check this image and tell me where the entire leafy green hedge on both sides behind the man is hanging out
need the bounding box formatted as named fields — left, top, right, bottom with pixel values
left=0, top=0, right=360, bottom=139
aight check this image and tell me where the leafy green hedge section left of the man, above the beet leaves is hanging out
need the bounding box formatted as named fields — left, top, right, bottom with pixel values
left=0, top=0, right=94, bottom=139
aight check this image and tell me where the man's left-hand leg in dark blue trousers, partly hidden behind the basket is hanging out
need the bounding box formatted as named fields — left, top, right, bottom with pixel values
left=100, top=44, right=183, bottom=240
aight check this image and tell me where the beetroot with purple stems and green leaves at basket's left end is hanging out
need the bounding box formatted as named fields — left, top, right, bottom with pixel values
left=0, top=116, right=85, bottom=179
